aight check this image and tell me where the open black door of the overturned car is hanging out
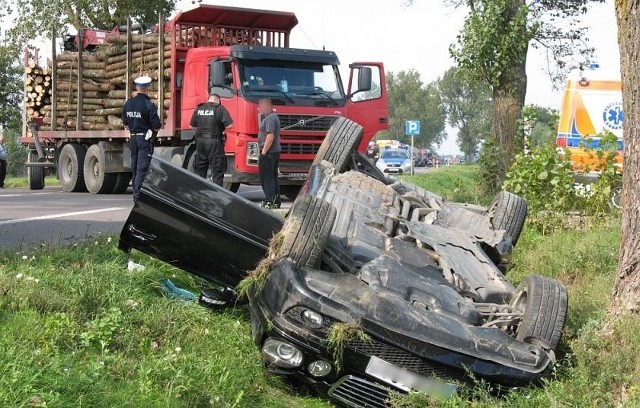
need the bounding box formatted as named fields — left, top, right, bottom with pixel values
left=120, top=157, right=282, bottom=286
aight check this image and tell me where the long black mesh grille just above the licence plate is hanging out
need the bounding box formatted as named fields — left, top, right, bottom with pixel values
left=347, top=340, right=468, bottom=381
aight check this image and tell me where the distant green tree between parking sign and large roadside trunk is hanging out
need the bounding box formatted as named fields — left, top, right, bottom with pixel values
left=438, top=67, right=492, bottom=162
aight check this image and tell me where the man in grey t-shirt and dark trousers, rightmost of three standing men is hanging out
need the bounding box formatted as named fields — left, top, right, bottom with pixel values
left=258, top=98, right=281, bottom=208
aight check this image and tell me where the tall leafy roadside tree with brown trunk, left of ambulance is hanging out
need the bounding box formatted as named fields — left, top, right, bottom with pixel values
left=430, top=0, right=605, bottom=188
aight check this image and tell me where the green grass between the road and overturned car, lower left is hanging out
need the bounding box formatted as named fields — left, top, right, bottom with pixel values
left=0, top=237, right=330, bottom=407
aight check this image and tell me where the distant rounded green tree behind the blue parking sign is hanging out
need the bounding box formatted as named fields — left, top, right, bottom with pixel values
left=380, top=70, right=447, bottom=148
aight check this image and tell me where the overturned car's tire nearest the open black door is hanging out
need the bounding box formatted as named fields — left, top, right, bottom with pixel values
left=276, top=196, right=336, bottom=268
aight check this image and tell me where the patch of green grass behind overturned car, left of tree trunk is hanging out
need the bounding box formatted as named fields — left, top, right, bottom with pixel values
left=403, top=165, right=493, bottom=205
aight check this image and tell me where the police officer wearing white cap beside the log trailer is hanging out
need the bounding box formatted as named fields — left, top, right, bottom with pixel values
left=122, top=76, right=162, bottom=202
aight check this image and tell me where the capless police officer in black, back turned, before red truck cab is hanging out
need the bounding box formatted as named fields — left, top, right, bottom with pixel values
left=191, top=94, right=233, bottom=186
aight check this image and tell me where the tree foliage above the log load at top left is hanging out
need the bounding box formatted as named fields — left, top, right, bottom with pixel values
left=0, top=0, right=176, bottom=46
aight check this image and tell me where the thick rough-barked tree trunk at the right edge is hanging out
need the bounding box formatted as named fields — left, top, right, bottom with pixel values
left=612, top=0, right=640, bottom=314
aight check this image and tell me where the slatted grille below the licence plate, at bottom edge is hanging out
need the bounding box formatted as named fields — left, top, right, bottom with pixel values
left=329, top=375, right=390, bottom=408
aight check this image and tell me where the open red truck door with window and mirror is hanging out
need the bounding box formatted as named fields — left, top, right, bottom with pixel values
left=347, top=62, right=389, bottom=152
